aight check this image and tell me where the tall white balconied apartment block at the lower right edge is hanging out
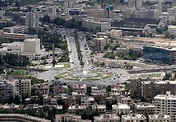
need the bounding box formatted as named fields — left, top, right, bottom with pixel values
left=154, top=91, right=176, bottom=122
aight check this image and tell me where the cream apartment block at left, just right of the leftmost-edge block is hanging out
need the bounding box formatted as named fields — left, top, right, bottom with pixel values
left=14, top=79, right=31, bottom=97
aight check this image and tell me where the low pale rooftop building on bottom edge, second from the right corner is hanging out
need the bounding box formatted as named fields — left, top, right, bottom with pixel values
left=121, top=113, right=147, bottom=122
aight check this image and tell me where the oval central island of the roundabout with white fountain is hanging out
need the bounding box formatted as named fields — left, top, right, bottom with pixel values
left=55, top=70, right=114, bottom=81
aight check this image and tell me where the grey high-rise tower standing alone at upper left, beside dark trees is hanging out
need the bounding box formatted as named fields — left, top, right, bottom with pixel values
left=25, top=12, right=39, bottom=28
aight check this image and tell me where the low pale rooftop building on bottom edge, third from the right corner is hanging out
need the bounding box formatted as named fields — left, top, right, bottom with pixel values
left=94, top=114, right=120, bottom=122
